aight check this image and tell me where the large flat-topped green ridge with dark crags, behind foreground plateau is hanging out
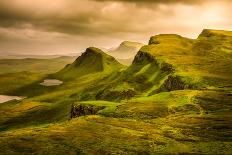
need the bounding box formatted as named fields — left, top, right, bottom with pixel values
left=78, top=30, right=232, bottom=101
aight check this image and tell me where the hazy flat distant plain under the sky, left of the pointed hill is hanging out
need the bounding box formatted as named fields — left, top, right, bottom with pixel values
left=0, top=56, right=75, bottom=74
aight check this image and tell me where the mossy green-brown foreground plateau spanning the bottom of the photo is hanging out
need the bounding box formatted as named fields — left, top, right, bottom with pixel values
left=0, top=91, right=232, bottom=154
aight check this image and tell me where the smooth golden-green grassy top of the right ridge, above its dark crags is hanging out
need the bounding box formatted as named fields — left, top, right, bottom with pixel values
left=144, top=30, right=232, bottom=88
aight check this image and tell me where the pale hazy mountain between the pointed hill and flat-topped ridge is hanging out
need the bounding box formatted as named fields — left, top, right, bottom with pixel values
left=107, top=41, right=144, bottom=63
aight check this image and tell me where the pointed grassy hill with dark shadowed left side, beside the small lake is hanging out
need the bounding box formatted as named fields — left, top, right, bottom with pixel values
left=55, top=47, right=123, bottom=80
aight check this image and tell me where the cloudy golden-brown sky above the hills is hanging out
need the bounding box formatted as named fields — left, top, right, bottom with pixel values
left=0, top=0, right=232, bottom=55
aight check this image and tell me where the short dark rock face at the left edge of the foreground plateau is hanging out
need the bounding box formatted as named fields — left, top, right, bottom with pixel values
left=71, top=104, right=105, bottom=118
